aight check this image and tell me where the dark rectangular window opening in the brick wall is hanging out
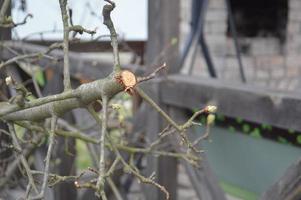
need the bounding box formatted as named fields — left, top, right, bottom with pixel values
left=228, top=0, right=288, bottom=41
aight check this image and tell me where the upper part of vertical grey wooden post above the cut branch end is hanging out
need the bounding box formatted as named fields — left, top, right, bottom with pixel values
left=146, top=0, right=180, bottom=71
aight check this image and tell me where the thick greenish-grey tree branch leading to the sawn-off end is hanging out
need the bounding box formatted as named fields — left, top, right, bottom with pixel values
left=0, top=76, right=123, bottom=121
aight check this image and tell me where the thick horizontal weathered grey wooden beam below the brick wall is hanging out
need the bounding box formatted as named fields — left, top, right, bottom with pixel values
left=161, top=75, right=301, bottom=131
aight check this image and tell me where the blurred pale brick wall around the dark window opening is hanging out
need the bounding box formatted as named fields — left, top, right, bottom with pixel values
left=180, top=0, right=301, bottom=90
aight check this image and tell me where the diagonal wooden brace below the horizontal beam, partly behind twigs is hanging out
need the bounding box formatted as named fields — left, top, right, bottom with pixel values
left=170, top=107, right=226, bottom=200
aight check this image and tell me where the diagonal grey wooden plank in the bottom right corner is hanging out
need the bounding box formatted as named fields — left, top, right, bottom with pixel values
left=260, top=158, right=301, bottom=200
